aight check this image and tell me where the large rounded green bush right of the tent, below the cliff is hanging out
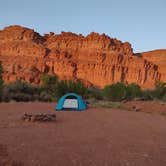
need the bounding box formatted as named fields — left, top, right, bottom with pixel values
left=103, top=82, right=127, bottom=101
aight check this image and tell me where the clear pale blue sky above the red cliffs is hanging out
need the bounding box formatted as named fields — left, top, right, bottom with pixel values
left=0, top=0, right=166, bottom=52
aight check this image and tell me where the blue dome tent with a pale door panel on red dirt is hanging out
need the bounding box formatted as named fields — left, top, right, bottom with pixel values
left=56, top=93, right=87, bottom=111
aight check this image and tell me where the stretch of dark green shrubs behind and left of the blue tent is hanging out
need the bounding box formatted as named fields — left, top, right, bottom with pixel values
left=2, top=75, right=87, bottom=102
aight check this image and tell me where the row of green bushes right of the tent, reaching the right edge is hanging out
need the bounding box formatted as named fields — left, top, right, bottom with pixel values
left=103, top=82, right=166, bottom=101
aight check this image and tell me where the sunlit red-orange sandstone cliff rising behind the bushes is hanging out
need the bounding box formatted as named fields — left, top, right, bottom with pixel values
left=0, top=25, right=166, bottom=88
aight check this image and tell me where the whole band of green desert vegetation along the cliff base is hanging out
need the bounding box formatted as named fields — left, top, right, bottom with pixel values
left=0, top=63, right=166, bottom=103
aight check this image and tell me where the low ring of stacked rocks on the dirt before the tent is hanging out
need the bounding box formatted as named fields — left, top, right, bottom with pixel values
left=22, top=114, right=56, bottom=122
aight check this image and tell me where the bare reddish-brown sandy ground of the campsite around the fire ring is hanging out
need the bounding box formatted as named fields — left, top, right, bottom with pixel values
left=0, top=102, right=166, bottom=166
